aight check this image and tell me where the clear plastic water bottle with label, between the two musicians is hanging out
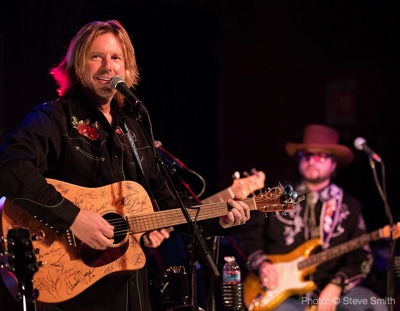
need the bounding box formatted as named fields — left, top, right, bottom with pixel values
left=221, top=256, right=243, bottom=310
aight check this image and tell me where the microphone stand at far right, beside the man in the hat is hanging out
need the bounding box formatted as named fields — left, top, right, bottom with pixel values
left=369, top=157, right=396, bottom=311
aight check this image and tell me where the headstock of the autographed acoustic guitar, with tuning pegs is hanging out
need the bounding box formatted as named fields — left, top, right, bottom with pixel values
left=254, top=184, right=305, bottom=213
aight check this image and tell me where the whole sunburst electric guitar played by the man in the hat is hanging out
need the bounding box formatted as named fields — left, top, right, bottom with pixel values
left=244, top=225, right=400, bottom=311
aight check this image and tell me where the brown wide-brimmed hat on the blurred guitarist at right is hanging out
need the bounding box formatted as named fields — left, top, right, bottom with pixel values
left=285, top=124, right=353, bottom=167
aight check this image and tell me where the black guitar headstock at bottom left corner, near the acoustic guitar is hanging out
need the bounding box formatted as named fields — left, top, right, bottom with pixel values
left=6, top=227, right=39, bottom=302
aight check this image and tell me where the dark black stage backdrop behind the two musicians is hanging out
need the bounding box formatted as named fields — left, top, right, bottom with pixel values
left=0, top=0, right=400, bottom=310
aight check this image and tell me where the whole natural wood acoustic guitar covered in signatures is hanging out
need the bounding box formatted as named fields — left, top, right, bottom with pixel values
left=0, top=179, right=298, bottom=303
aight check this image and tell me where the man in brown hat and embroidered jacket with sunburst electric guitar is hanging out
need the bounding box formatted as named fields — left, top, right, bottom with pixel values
left=236, top=124, right=387, bottom=311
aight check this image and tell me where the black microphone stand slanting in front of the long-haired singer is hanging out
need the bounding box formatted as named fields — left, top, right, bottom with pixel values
left=126, top=99, right=220, bottom=311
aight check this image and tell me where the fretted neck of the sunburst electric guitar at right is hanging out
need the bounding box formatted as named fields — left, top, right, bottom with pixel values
left=298, top=229, right=382, bottom=270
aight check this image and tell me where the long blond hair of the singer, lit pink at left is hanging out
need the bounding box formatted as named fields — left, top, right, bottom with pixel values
left=50, top=20, right=139, bottom=103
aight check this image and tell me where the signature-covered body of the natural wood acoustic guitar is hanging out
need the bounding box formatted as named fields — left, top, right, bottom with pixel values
left=0, top=179, right=154, bottom=303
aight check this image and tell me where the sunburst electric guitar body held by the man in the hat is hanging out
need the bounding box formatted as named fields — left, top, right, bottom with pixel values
left=244, top=239, right=320, bottom=311
